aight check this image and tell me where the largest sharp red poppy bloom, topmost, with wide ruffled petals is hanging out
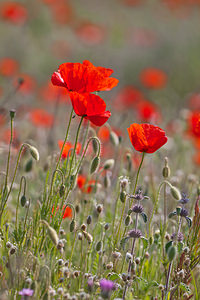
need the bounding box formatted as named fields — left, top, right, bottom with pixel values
left=51, top=60, right=118, bottom=93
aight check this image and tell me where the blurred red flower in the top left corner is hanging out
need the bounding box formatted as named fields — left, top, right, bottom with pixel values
left=0, top=1, right=28, bottom=25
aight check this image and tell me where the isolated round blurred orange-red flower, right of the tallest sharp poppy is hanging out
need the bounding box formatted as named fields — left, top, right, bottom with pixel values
left=140, top=68, right=167, bottom=89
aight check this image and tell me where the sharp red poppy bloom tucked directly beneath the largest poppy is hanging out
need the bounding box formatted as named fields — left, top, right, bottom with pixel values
left=70, top=92, right=111, bottom=126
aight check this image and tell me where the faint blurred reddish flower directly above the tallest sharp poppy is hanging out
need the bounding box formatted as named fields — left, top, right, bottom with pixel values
left=76, top=23, right=105, bottom=46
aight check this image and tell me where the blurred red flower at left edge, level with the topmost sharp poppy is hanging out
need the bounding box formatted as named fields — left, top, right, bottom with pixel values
left=0, top=57, right=19, bottom=77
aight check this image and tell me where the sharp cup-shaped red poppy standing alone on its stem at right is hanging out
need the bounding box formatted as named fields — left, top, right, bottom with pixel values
left=127, top=123, right=167, bottom=153
